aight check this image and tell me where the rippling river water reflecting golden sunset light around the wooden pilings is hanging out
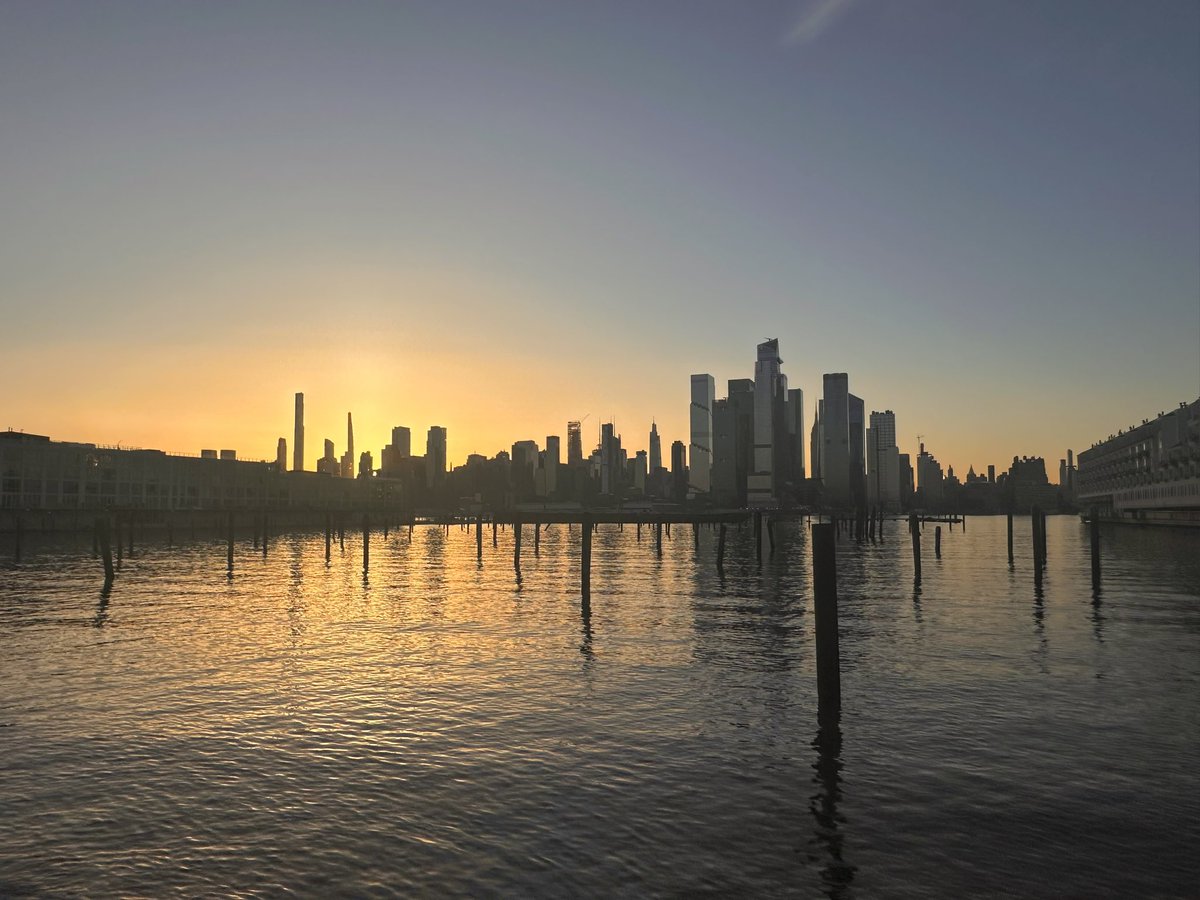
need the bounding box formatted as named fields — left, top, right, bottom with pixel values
left=0, top=517, right=1200, bottom=898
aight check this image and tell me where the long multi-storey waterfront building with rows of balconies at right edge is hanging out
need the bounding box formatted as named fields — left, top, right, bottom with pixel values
left=1075, top=400, right=1200, bottom=524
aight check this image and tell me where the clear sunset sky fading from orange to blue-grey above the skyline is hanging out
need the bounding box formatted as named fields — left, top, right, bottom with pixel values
left=0, top=0, right=1200, bottom=479
